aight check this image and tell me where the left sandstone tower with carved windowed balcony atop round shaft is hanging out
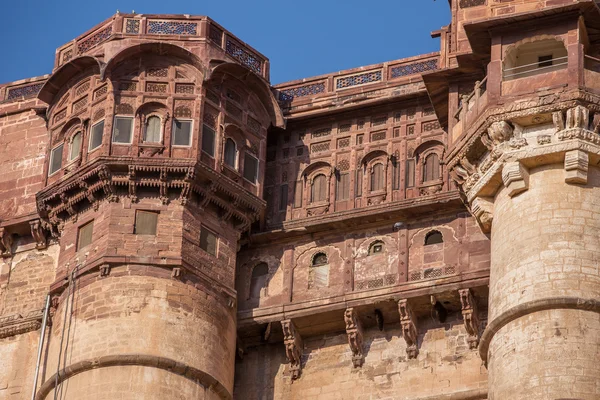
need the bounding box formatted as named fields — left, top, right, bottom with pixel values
left=28, top=14, right=283, bottom=400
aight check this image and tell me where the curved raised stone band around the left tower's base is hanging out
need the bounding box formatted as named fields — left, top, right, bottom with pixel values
left=35, top=354, right=232, bottom=400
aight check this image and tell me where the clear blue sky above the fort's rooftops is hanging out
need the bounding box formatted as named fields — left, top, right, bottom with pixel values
left=0, top=0, right=450, bottom=84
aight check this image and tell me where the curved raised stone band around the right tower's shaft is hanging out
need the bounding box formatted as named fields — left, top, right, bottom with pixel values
left=479, top=297, right=600, bottom=364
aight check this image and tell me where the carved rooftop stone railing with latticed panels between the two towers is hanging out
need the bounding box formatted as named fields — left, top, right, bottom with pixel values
left=276, top=53, right=439, bottom=105
